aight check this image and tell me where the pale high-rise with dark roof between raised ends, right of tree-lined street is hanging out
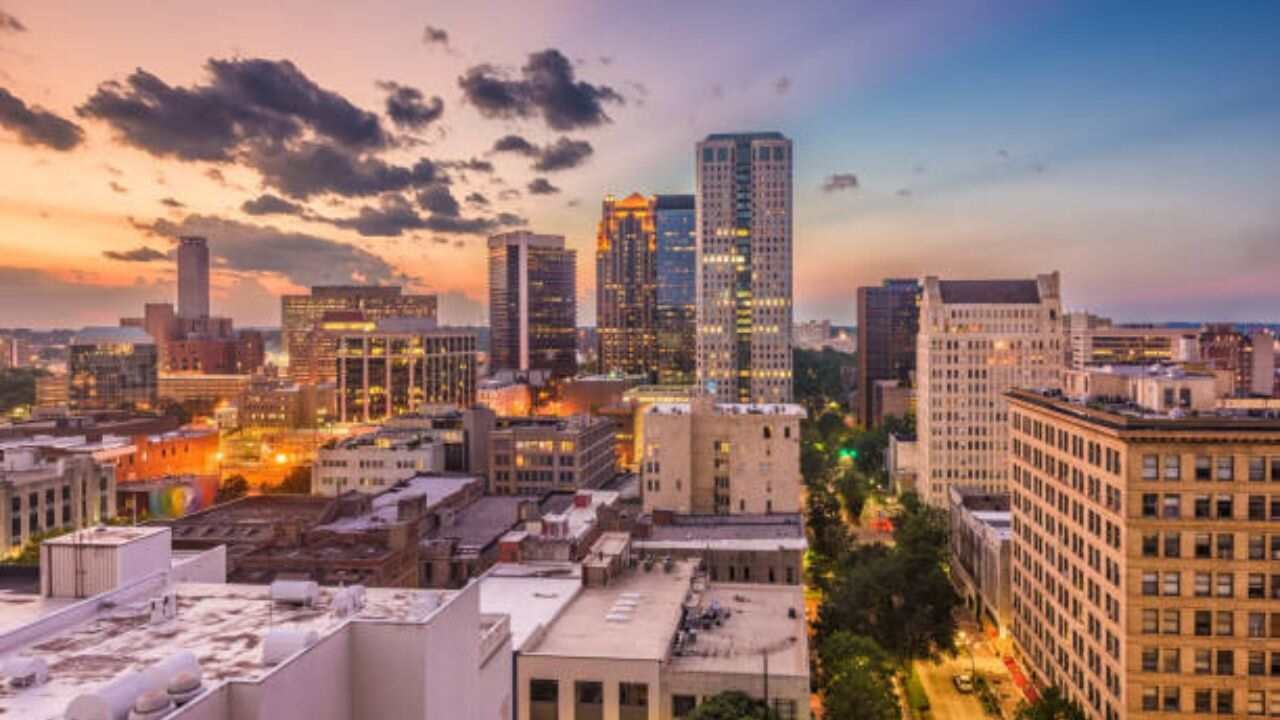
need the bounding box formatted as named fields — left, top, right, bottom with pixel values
left=915, top=273, right=1065, bottom=510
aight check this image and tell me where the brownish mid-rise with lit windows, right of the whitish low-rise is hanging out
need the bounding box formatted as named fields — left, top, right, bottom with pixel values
left=489, top=415, right=618, bottom=495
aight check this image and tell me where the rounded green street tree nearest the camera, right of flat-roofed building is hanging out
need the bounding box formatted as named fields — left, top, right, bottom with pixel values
left=818, top=632, right=902, bottom=720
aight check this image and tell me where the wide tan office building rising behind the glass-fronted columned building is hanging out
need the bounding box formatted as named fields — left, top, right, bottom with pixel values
left=280, top=286, right=436, bottom=383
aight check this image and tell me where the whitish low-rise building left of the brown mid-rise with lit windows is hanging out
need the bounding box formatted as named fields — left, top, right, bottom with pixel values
left=311, top=430, right=444, bottom=497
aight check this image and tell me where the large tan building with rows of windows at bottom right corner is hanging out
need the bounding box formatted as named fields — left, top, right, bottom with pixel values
left=1009, top=391, right=1280, bottom=720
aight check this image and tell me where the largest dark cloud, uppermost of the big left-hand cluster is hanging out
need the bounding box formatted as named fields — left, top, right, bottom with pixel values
left=77, top=59, right=388, bottom=161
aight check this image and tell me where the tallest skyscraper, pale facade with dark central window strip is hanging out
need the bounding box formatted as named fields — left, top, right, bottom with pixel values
left=696, top=132, right=791, bottom=402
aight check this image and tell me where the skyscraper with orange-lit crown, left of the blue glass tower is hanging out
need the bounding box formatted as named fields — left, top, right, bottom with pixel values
left=595, top=193, right=658, bottom=380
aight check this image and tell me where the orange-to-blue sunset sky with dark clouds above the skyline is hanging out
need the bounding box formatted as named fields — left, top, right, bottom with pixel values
left=0, top=0, right=1280, bottom=328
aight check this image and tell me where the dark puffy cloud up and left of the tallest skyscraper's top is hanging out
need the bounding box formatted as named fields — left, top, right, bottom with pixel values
left=458, top=49, right=626, bottom=131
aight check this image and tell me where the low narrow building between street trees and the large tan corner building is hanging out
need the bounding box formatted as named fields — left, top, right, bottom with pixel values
left=948, top=486, right=1012, bottom=635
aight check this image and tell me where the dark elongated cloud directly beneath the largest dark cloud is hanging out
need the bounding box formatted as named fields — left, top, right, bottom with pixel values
left=256, top=142, right=445, bottom=199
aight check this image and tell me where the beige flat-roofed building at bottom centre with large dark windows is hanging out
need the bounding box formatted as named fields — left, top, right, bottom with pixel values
left=512, top=533, right=810, bottom=720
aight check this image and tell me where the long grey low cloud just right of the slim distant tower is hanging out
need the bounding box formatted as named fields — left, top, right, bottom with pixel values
left=140, top=214, right=399, bottom=286
